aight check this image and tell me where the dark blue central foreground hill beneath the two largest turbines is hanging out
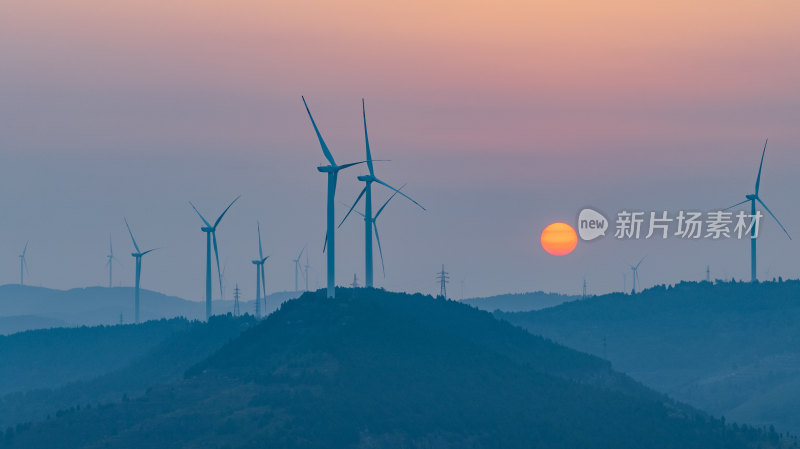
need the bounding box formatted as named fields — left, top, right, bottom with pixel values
left=0, top=289, right=778, bottom=449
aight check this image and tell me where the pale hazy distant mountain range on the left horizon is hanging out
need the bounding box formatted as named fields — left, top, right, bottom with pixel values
left=0, top=284, right=300, bottom=335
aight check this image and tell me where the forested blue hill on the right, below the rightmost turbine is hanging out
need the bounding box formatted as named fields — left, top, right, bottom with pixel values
left=498, top=281, right=800, bottom=433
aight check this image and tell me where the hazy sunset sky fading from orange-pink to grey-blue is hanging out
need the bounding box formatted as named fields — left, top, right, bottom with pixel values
left=0, top=0, right=800, bottom=300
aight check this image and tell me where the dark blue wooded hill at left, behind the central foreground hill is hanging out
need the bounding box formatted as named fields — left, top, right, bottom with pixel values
left=0, top=315, right=256, bottom=428
